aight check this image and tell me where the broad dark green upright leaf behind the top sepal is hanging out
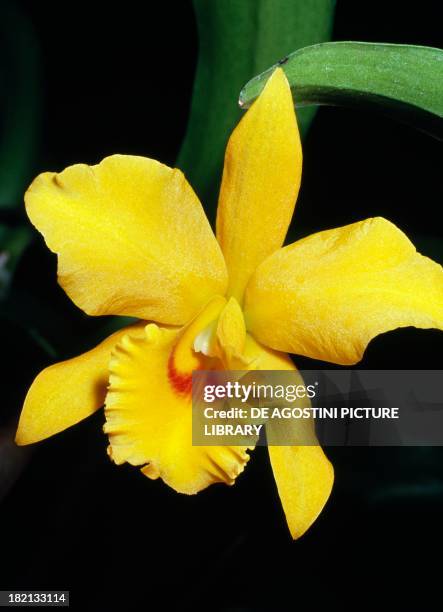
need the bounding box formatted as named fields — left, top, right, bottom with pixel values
left=177, top=0, right=335, bottom=208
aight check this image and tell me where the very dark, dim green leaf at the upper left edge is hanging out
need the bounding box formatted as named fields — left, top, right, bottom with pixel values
left=0, top=0, right=40, bottom=209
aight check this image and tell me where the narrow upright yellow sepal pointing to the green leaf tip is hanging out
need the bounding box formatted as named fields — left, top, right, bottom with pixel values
left=217, top=69, right=302, bottom=304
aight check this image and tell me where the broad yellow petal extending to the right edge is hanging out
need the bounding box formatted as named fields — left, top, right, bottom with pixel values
left=245, top=218, right=443, bottom=365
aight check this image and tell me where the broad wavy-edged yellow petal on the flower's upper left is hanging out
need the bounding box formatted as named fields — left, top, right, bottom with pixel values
left=25, top=155, right=227, bottom=325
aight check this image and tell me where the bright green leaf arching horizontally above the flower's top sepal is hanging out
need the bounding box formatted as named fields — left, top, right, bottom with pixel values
left=240, top=42, right=443, bottom=138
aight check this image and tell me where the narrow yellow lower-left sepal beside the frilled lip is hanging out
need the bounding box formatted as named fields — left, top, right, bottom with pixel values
left=16, top=323, right=145, bottom=445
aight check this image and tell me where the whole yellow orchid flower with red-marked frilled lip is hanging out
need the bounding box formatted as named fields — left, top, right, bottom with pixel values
left=17, top=69, right=443, bottom=538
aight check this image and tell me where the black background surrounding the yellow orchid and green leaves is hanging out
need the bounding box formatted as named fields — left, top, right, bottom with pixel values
left=0, top=0, right=443, bottom=611
